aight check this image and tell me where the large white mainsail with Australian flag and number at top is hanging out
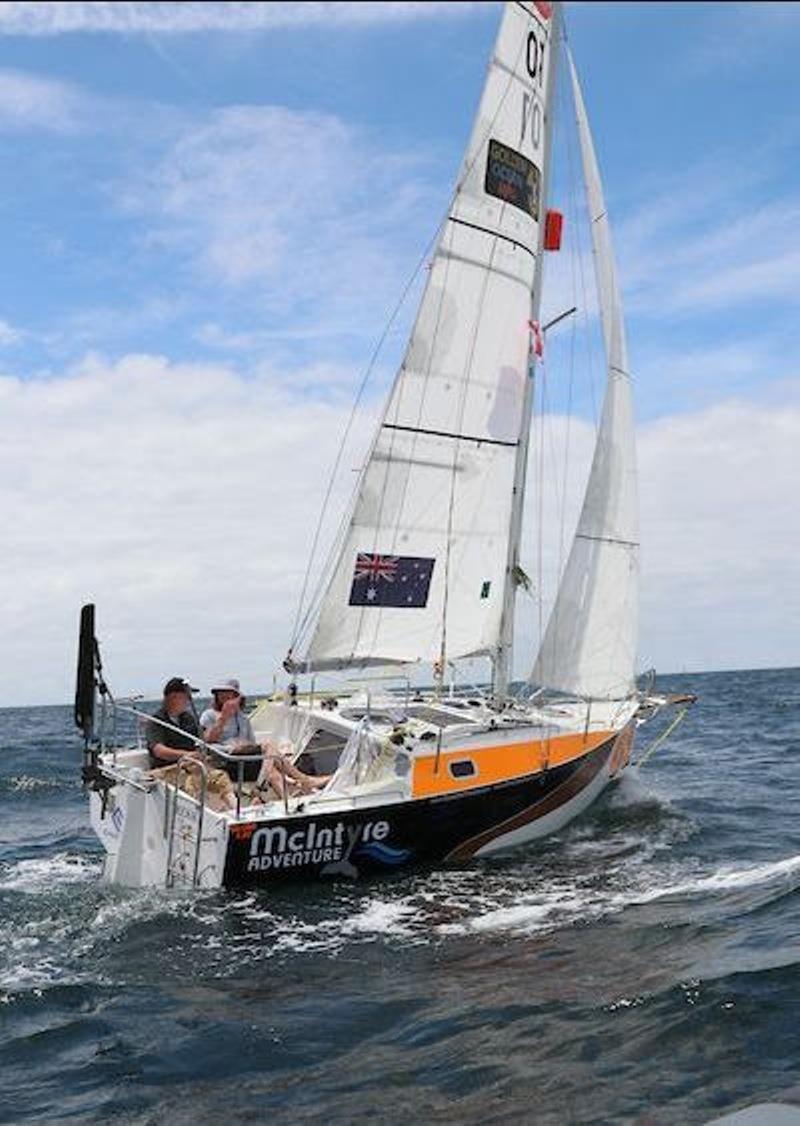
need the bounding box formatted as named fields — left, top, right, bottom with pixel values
left=303, top=3, right=557, bottom=670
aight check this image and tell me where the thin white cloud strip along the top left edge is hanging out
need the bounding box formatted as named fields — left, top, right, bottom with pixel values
left=0, top=0, right=486, bottom=35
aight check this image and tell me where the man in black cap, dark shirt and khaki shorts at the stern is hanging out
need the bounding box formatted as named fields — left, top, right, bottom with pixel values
left=145, top=677, right=237, bottom=810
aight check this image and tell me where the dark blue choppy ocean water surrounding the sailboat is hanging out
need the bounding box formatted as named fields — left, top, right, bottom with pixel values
left=0, top=669, right=800, bottom=1124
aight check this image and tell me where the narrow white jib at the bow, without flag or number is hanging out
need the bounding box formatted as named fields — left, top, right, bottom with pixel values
left=531, top=59, right=639, bottom=699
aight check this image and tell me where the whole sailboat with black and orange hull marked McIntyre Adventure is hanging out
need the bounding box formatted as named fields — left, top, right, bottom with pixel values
left=77, top=2, right=694, bottom=887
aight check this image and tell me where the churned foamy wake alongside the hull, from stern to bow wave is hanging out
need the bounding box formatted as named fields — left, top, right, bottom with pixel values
left=0, top=828, right=800, bottom=1002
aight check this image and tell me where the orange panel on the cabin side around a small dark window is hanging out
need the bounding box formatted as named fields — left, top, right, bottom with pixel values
left=412, top=731, right=613, bottom=797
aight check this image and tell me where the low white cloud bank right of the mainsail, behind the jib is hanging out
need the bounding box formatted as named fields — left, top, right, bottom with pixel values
left=517, top=387, right=800, bottom=674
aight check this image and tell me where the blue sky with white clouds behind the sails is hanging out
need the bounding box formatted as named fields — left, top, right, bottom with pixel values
left=0, top=2, right=800, bottom=706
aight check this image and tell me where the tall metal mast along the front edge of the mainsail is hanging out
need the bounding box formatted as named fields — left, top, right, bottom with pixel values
left=492, top=3, right=561, bottom=700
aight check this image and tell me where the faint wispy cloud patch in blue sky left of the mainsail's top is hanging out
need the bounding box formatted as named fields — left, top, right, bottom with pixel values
left=125, top=106, right=445, bottom=340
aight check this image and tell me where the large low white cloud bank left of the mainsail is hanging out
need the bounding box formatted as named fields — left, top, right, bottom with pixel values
left=0, top=356, right=371, bottom=701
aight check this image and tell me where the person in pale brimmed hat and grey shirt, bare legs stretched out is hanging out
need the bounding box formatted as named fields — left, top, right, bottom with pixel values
left=199, top=677, right=328, bottom=797
